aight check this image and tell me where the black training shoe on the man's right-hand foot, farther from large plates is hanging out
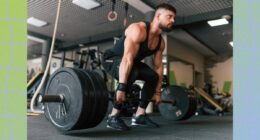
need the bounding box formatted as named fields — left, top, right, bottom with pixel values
left=131, top=114, right=159, bottom=127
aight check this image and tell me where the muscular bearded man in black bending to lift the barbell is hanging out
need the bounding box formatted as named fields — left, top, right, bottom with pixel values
left=102, top=4, right=176, bottom=130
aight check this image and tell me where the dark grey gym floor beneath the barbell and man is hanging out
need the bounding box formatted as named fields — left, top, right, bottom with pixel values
left=27, top=113, right=233, bottom=140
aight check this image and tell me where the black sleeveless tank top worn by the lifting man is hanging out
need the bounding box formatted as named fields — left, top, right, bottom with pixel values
left=105, top=22, right=161, bottom=62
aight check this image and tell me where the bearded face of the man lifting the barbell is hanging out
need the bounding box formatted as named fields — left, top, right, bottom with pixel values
left=159, top=9, right=175, bottom=31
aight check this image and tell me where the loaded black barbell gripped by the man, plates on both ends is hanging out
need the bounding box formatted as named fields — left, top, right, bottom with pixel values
left=38, top=68, right=197, bottom=133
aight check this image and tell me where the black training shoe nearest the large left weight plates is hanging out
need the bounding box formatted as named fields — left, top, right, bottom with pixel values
left=107, top=115, right=130, bottom=131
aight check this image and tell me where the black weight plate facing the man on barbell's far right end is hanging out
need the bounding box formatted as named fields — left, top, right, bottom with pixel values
left=159, top=86, right=194, bottom=121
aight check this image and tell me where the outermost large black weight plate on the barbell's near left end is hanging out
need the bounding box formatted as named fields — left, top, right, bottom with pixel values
left=45, top=68, right=85, bottom=131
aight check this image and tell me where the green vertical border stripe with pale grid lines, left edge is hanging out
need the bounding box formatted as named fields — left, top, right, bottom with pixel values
left=0, top=0, right=27, bottom=140
